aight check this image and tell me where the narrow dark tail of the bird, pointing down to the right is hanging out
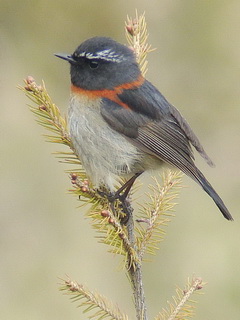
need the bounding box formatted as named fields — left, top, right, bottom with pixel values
left=195, top=169, right=233, bottom=220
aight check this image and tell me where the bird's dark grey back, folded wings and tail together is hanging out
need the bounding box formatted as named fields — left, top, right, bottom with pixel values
left=101, top=86, right=233, bottom=220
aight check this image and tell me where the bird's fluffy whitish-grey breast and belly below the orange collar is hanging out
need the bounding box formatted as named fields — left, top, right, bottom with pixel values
left=68, top=96, right=144, bottom=189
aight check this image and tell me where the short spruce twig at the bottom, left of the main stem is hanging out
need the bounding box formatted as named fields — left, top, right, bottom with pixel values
left=60, top=279, right=128, bottom=320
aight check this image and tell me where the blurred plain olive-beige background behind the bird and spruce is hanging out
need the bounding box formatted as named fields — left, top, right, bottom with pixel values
left=0, top=0, right=240, bottom=320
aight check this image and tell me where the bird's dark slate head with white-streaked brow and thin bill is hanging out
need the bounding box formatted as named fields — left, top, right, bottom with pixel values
left=56, top=37, right=141, bottom=90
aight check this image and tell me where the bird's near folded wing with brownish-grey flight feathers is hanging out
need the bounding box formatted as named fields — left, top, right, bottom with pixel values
left=101, top=100, right=195, bottom=180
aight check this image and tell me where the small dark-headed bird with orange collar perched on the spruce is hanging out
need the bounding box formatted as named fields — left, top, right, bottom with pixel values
left=55, top=37, right=233, bottom=220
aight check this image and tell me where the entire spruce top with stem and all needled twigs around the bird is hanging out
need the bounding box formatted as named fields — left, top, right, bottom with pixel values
left=20, top=8, right=206, bottom=320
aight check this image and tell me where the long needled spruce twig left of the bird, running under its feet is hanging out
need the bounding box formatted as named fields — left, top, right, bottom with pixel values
left=20, top=76, right=142, bottom=268
